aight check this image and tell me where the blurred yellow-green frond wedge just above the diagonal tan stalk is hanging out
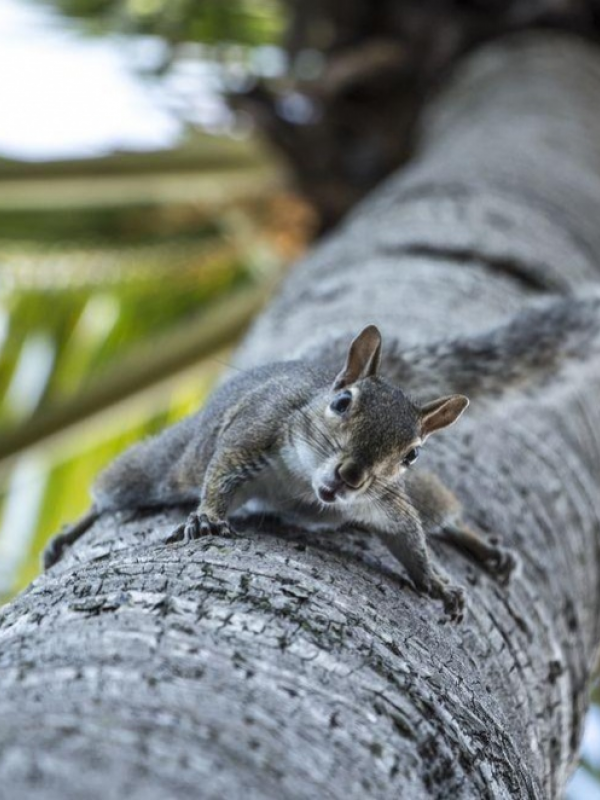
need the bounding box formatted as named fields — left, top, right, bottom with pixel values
left=0, top=240, right=241, bottom=430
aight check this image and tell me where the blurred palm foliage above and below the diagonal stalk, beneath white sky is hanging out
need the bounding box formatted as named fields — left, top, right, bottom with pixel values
left=0, top=137, right=310, bottom=599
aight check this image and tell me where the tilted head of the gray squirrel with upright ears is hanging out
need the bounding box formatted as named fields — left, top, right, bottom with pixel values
left=307, top=325, right=469, bottom=504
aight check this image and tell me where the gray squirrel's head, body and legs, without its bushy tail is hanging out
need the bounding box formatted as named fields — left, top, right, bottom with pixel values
left=44, top=325, right=515, bottom=621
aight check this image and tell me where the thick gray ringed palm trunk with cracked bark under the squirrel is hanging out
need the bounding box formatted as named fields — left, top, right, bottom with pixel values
left=0, top=34, right=600, bottom=800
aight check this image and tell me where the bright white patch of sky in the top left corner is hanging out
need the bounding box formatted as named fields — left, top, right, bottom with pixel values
left=0, top=0, right=181, bottom=160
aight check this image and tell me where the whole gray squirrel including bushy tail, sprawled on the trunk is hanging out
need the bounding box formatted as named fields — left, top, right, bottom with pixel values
left=55, top=288, right=600, bottom=620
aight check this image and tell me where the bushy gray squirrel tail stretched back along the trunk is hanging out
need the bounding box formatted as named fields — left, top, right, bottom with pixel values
left=394, top=289, right=600, bottom=399
